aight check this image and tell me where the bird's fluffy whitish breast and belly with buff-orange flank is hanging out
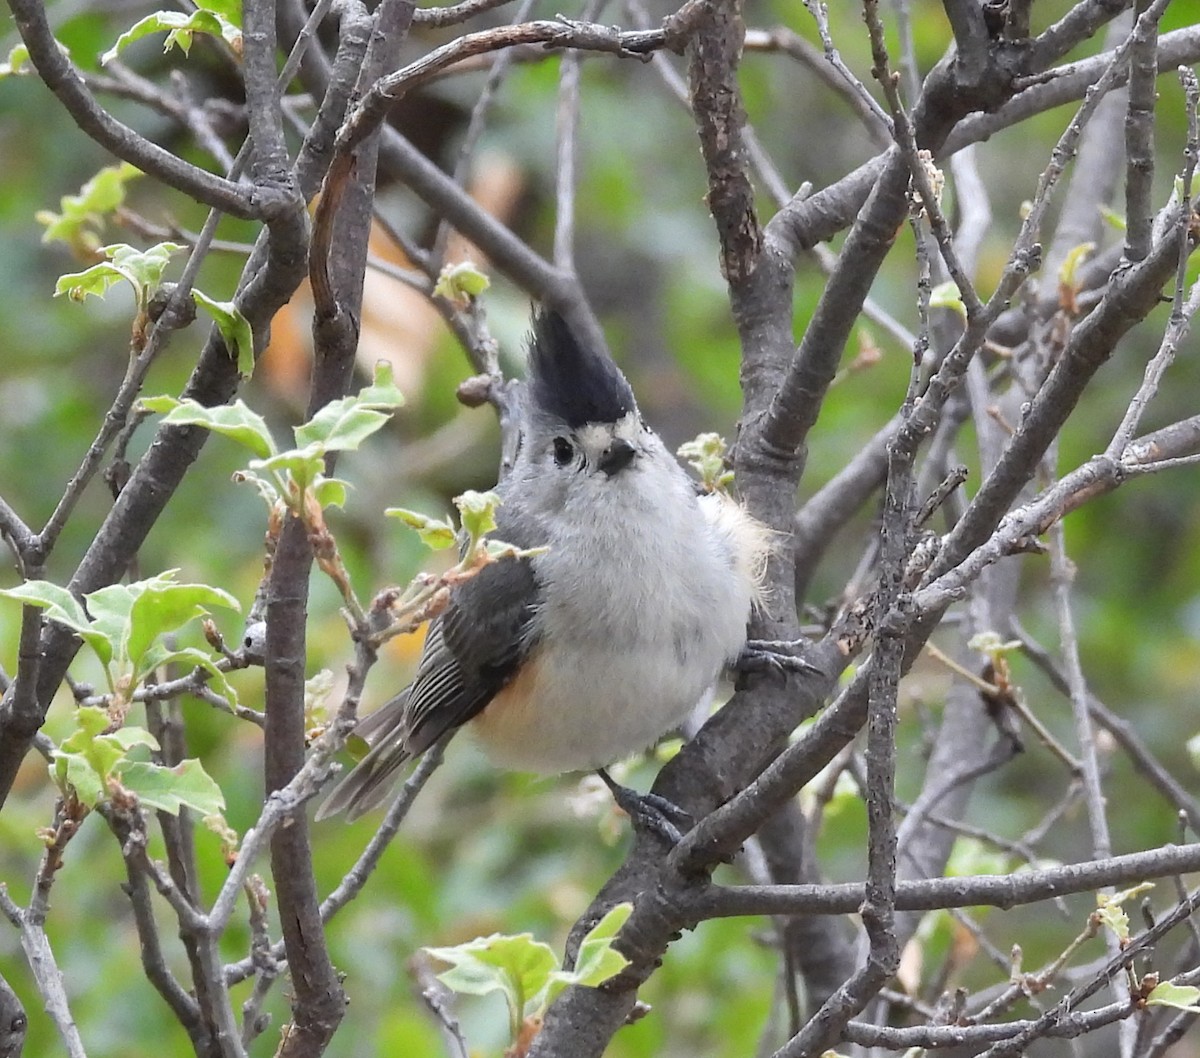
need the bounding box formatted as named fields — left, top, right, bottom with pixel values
left=473, top=451, right=768, bottom=774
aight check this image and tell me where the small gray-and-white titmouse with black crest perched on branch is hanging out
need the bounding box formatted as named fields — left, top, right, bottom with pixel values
left=318, top=311, right=769, bottom=818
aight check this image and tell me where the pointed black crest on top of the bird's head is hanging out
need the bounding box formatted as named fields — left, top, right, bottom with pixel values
left=529, top=308, right=637, bottom=429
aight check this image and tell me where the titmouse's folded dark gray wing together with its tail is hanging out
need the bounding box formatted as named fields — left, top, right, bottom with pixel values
left=317, top=507, right=538, bottom=819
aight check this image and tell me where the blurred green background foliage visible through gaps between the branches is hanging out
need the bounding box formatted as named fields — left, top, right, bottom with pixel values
left=0, top=0, right=1200, bottom=1058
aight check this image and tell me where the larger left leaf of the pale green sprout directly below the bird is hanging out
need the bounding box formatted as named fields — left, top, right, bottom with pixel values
left=425, top=933, right=558, bottom=1024
